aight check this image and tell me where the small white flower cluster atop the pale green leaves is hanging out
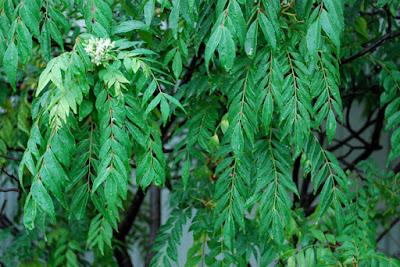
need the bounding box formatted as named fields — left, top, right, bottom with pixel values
left=85, top=37, right=115, bottom=66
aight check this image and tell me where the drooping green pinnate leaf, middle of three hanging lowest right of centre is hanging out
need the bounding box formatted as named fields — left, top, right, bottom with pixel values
left=252, top=133, right=298, bottom=244
